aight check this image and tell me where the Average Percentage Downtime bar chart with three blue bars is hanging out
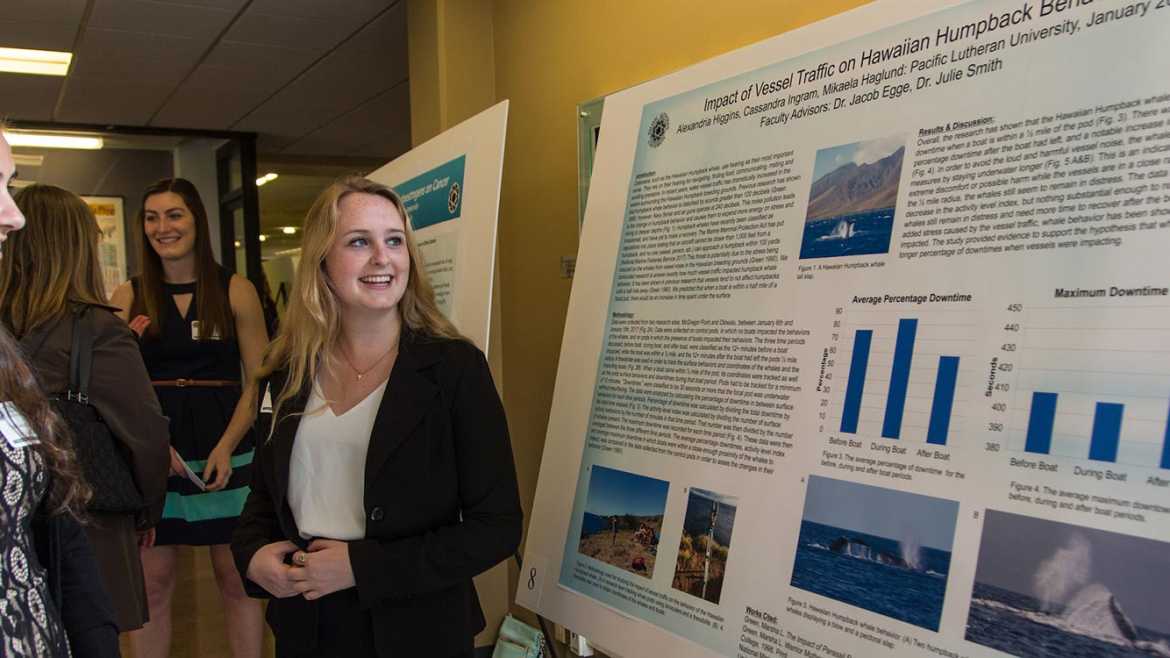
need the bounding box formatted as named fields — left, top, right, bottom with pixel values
left=833, top=307, right=973, bottom=446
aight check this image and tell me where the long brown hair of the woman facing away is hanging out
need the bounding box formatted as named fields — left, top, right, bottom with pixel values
left=0, top=185, right=109, bottom=340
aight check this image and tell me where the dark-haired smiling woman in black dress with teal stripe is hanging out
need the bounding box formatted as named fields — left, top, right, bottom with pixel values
left=112, top=178, right=268, bottom=658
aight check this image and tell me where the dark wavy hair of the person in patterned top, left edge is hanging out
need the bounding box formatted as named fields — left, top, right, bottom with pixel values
left=0, top=328, right=91, bottom=518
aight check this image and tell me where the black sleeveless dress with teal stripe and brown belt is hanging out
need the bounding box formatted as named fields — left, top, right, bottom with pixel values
left=133, top=268, right=254, bottom=546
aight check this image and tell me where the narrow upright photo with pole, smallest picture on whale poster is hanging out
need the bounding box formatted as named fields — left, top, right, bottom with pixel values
left=670, top=488, right=738, bottom=604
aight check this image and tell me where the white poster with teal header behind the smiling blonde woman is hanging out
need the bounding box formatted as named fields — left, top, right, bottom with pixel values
left=370, top=101, right=508, bottom=352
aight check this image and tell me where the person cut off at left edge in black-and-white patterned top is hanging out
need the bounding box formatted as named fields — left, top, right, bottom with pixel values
left=0, top=123, right=118, bottom=658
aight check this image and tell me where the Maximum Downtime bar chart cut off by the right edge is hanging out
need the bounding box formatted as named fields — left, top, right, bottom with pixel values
left=1009, top=304, right=1170, bottom=469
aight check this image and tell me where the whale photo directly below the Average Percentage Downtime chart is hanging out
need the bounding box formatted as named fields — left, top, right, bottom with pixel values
left=792, top=475, right=958, bottom=631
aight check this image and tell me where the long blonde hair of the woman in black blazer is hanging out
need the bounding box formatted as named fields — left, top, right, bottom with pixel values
left=256, top=176, right=463, bottom=437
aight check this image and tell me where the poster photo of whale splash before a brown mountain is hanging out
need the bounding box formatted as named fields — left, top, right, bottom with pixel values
left=800, top=135, right=906, bottom=259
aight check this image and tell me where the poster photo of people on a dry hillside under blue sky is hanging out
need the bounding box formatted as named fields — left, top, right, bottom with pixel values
left=577, top=466, right=670, bottom=578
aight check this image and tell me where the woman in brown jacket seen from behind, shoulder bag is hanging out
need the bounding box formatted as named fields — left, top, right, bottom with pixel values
left=0, top=185, right=171, bottom=632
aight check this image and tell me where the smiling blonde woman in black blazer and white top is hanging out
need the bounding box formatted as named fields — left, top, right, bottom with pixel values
left=232, top=178, right=522, bottom=658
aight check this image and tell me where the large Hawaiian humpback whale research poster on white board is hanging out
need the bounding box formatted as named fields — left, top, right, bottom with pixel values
left=518, top=0, right=1170, bottom=658
